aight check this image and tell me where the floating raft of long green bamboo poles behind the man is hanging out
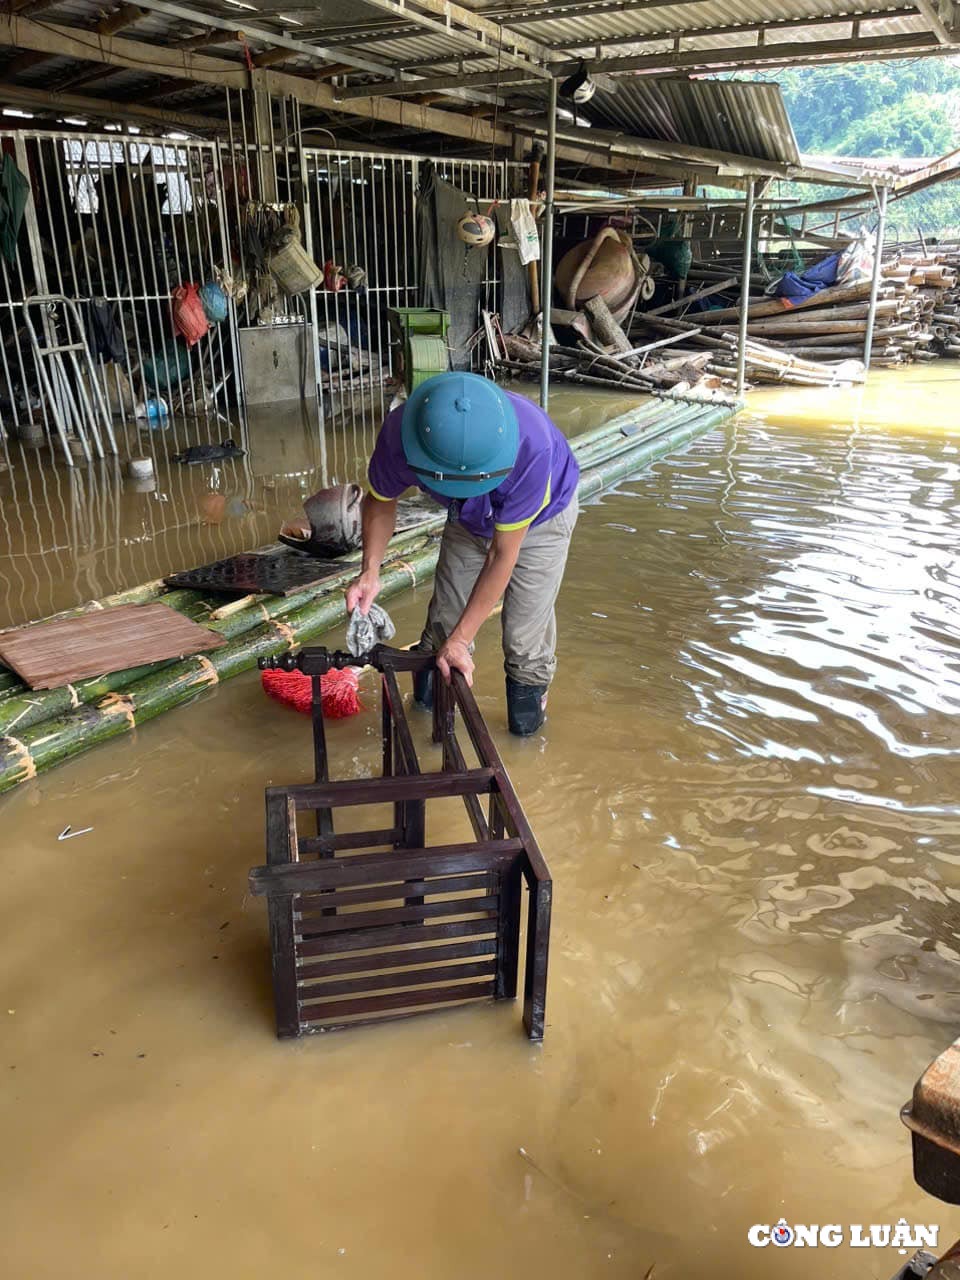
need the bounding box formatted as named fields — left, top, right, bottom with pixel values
left=0, top=401, right=731, bottom=792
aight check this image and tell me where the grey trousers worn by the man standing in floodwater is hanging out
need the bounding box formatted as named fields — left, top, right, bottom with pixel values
left=419, top=494, right=580, bottom=687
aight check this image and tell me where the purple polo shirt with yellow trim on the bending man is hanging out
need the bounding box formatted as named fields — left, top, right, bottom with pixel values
left=367, top=392, right=580, bottom=538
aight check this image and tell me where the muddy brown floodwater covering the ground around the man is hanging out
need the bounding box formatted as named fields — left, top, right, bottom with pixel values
left=0, top=365, right=960, bottom=1280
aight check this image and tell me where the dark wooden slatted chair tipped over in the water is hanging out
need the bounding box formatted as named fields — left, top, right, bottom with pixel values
left=250, top=645, right=552, bottom=1041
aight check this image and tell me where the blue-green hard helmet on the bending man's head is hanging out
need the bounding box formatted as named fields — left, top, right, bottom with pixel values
left=401, top=372, right=520, bottom=498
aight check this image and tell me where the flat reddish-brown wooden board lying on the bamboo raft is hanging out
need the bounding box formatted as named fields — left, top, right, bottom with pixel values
left=0, top=604, right=225, bottom=689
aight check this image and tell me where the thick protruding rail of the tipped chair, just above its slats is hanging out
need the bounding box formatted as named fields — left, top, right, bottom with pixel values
left=247, top=834, right=524, bottom=896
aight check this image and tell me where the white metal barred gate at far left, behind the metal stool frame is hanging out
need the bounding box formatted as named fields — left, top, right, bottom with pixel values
left=0, top=132, right=237, bottom=452
